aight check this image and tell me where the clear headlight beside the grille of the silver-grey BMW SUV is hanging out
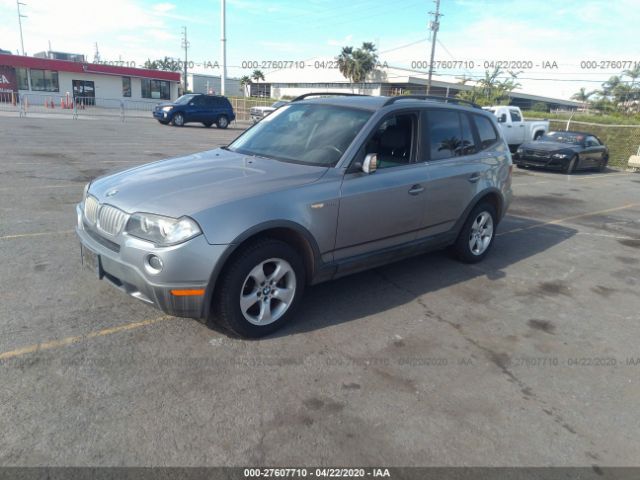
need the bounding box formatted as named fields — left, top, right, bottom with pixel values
left=125, top=213, right=202, bottom=247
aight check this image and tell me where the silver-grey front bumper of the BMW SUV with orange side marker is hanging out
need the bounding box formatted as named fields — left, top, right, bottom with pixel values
left=76, top=204, right=227, bottom=318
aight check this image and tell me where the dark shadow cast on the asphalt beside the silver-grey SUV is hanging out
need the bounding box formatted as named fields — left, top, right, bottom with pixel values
left=269, top=216, right=577, bottom=338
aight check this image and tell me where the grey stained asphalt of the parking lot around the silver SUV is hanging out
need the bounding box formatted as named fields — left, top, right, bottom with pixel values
left=0, top=116, right=640, bottom=466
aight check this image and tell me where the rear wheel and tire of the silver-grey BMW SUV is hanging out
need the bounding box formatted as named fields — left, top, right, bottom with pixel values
left=453, top=202, right=497, bottom=263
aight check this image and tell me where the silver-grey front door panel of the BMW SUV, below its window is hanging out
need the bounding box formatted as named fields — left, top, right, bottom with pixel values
left=335, top=163, right=428, bottom=260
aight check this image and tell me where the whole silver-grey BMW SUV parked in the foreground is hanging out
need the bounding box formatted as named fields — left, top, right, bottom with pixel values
left=77, top=94, right=512, bottom=337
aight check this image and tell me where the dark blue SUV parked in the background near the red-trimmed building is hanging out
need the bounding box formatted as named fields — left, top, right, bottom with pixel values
left=153, top=93, right=236, bottom=128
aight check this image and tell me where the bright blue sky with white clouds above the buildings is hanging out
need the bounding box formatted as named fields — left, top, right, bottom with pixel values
left=0, top=0, right=640, bottom=98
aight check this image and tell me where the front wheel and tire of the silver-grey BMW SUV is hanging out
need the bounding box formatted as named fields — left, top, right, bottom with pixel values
left=211, top=238, right=306, bottom=338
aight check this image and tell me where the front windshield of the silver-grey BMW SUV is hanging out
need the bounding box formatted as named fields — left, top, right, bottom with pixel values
left=228, top=104, right=372, bottom=166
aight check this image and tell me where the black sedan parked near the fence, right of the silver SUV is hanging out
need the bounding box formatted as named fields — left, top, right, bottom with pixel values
left=513, top=132, right=609, bottom=173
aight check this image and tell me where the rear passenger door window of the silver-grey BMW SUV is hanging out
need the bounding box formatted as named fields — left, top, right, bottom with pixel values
left=425, top=110, right=476, bottom=160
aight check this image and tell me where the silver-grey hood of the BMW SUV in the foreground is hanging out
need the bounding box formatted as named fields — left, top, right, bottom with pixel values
left=89, top=148, right=328, bottom=218
